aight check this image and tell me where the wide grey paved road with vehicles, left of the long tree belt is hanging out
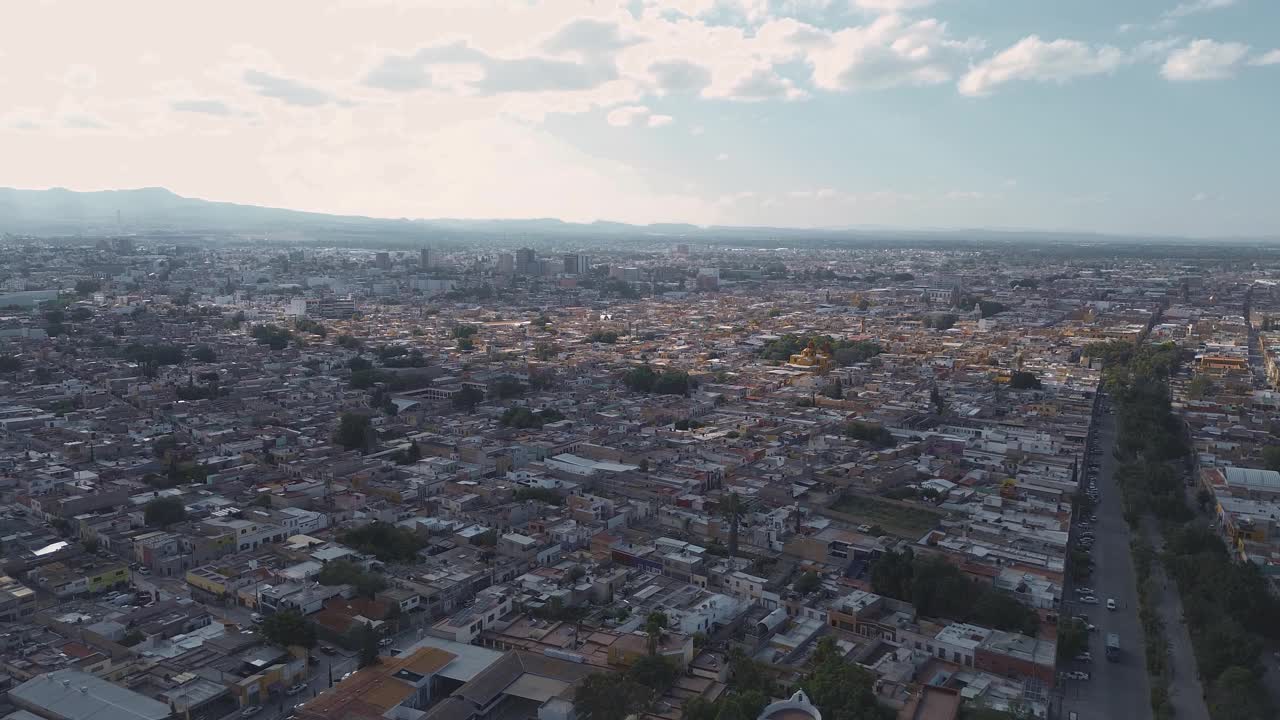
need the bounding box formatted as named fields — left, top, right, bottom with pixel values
left=1059, top=397, right=1152, bottom=720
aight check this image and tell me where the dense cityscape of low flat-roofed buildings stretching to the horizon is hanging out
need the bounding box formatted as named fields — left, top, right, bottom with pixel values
left=0, top=232, right=1280, bottom=720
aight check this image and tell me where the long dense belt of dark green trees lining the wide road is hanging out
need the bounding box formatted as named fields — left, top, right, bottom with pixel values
left=1105, top=342, right=1280, bottom=720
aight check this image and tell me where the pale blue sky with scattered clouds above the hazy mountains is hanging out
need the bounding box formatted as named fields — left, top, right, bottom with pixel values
left=0, top=0, right=1280, bottom=237
